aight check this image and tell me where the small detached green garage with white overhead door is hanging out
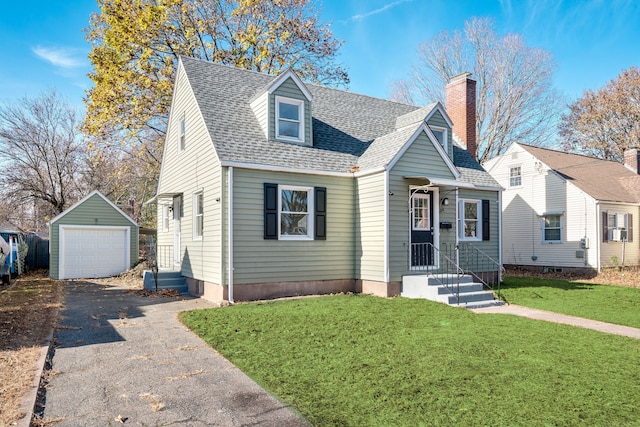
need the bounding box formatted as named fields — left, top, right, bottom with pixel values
left=49, top=191, right=139, bottom=279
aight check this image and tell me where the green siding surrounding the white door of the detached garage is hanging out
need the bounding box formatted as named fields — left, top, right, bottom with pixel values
left=49, top=194, right=138, bottom=279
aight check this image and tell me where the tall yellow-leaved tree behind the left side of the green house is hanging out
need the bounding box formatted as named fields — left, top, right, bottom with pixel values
left=83, top=0, right=348, bottom=207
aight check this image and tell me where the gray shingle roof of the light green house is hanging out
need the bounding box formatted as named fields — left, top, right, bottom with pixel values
left=182, top=58, right=497, bottom=186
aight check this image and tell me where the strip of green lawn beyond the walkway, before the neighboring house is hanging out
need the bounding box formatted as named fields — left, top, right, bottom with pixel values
left=500, top=277, right=640, bottom=328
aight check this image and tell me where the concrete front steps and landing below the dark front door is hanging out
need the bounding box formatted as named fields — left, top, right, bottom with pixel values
left=400, top=274, right=504, bottom=309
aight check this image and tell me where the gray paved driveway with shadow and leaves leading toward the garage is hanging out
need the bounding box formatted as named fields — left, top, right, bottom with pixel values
left=37, top=281, right=307, bottom=426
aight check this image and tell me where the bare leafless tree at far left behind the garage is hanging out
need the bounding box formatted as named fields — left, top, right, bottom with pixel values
left=0, top=90, right=84, bottom=224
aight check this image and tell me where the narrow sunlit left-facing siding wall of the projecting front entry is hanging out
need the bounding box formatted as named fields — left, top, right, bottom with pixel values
left=355, top=172, right=387, bottom=281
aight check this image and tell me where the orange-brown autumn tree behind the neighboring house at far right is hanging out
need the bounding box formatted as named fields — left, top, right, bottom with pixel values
left=559, top=67, right=640, bottom=161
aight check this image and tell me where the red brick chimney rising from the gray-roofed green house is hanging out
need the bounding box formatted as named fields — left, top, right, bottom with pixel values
left=446, top=73, right=478, bottom=159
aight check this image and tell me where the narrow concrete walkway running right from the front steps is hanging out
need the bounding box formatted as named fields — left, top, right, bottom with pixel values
left=471, top=304, right=640, bottom=339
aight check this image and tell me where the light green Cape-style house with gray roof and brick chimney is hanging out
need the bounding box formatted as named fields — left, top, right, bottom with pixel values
left=155, top=58, right=501, bottom=301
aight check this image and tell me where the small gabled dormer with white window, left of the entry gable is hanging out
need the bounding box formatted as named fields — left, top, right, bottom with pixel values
left=251, top=69, right=313, bottom=147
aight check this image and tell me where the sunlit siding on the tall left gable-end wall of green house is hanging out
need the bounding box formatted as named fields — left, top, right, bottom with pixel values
left=158, top=69, right=222, bottom=283
